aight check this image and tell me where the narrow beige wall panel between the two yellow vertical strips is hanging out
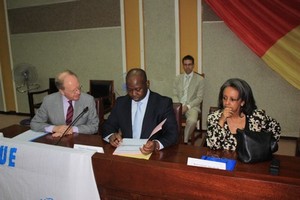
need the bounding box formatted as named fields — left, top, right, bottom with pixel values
left=144, top=0, right=176, bottom=97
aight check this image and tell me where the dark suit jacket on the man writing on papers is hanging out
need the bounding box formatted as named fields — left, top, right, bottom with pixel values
left=103, top=91, right=178, bottom=147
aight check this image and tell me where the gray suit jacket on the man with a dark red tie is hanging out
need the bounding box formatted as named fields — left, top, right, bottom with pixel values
left=30, top=92, right=99, bottom=134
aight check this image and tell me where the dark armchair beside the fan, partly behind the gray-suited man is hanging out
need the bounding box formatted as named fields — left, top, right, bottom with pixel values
left=28, top=78, right=58, bottom=118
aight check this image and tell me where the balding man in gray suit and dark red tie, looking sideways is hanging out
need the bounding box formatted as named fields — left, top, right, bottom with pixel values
left=30, top=70, right=99, bottom=137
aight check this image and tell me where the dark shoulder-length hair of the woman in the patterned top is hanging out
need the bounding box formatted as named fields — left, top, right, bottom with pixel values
left=218, top=78, right=257, bottom=115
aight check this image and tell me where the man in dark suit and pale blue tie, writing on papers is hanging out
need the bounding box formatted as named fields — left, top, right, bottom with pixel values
left=102, top=68, right=178, bottom=154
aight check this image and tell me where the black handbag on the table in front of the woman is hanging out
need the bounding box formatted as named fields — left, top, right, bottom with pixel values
left=236, top=129, right=278, bottom=163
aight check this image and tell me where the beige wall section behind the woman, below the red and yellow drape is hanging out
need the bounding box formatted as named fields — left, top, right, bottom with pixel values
left=203, top=22, right=300, bottom=137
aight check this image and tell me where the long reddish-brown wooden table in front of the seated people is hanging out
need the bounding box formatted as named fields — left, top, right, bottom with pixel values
left=0, top=125, right=300, bottom=199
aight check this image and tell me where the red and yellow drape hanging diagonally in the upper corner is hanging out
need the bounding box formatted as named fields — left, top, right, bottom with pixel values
left=205, top=0, right=300, bottom=89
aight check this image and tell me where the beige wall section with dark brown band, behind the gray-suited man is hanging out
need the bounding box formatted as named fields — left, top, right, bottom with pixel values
left=8, top=0, right=123, bottom=113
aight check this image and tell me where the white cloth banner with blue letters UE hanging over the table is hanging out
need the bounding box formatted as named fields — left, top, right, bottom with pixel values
left=0, top=138, right=100, bottom=200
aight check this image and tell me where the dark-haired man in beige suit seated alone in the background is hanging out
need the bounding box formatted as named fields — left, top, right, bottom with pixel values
left=173, top=55, right=204, bottom=144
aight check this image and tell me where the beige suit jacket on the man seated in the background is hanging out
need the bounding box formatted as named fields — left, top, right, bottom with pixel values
left=172, top=72, right=204, bottom=111
